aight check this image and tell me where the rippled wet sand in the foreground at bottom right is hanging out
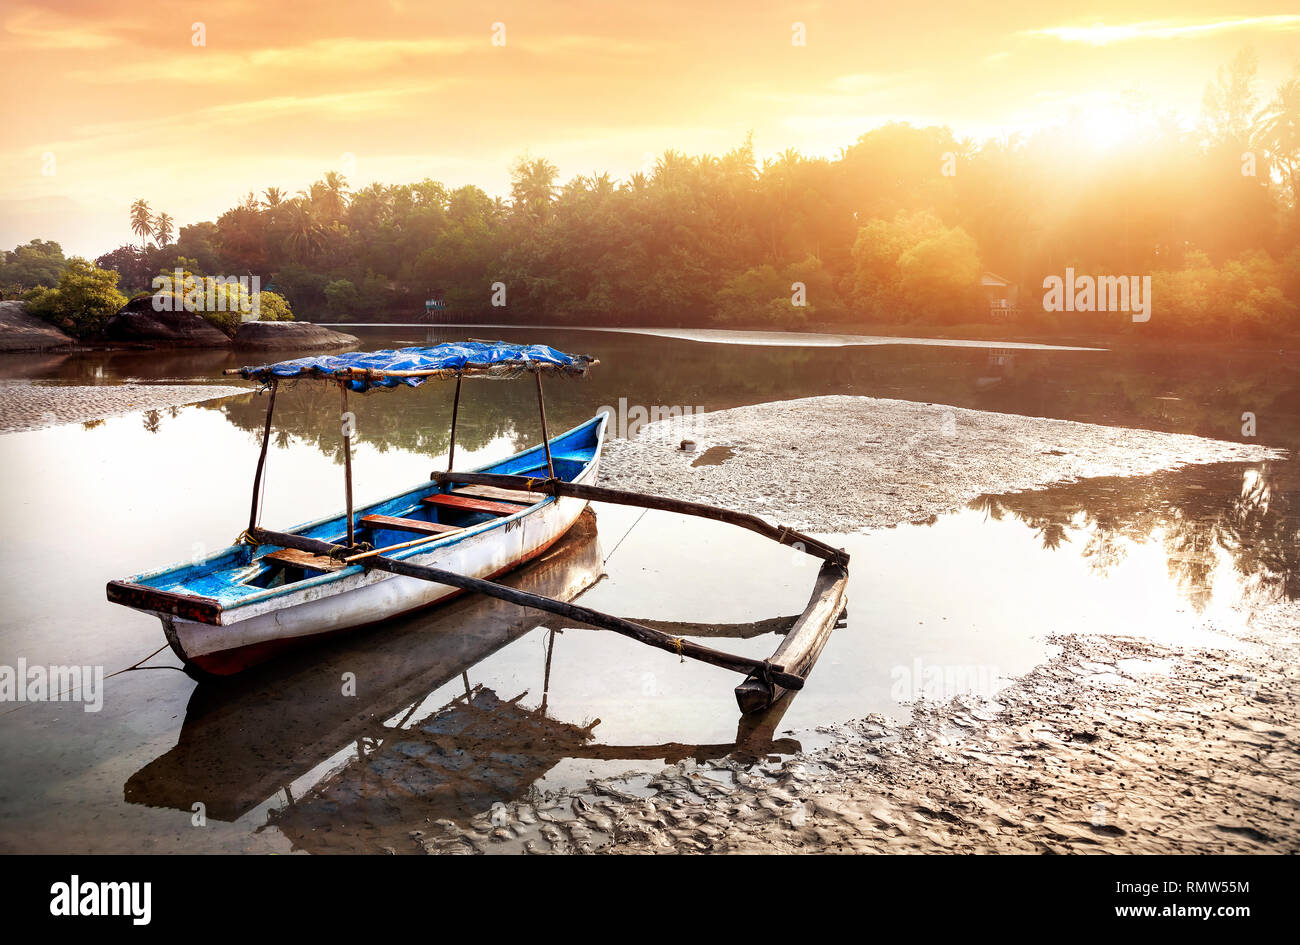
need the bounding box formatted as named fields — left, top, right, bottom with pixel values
left=417, top=604, right=1300, bottom=854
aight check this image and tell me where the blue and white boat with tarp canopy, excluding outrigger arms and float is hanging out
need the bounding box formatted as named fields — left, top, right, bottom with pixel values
left=108, top=342, right=606, bottom=676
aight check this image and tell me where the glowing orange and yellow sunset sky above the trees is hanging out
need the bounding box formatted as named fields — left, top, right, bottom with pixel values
left=0, top=0, right=1300, bottom=256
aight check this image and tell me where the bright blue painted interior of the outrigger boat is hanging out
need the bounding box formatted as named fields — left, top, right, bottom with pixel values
left=127, top=415, right=605, bottom=607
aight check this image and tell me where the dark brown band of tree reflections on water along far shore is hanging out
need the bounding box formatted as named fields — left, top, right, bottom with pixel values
left=0, top=326, right=1300, bottom=450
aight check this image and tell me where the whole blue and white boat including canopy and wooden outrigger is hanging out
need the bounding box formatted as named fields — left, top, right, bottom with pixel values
left=108, top=342, right=849, bottom=712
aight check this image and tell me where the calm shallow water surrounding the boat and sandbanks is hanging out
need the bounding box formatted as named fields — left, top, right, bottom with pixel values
left=0, top=328, right=1300, bottom=851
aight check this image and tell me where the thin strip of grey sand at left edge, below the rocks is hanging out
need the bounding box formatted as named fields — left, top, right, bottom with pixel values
left=0, top=383, right=248, bottom=433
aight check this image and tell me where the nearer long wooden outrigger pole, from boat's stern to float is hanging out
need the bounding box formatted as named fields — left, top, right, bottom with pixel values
left=245, top=528, right=803, bottom=690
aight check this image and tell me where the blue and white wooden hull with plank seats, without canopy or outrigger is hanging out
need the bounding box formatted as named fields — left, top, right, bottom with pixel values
left=109, top=416, right=605, bottom=676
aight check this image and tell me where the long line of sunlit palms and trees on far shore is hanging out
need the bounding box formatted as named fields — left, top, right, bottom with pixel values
left=0, top=52, right=1300, bottom=338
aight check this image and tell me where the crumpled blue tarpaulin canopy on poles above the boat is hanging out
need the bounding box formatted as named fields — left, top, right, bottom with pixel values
left=228, top=342, right=597, bottom=391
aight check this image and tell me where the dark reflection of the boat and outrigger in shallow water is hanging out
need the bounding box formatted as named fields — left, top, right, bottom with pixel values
left=125, top=510, right=800, bottom=851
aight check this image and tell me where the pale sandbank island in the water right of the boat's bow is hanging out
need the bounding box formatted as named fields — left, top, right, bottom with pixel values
left=601, top=396, right=1287, bottom=533
